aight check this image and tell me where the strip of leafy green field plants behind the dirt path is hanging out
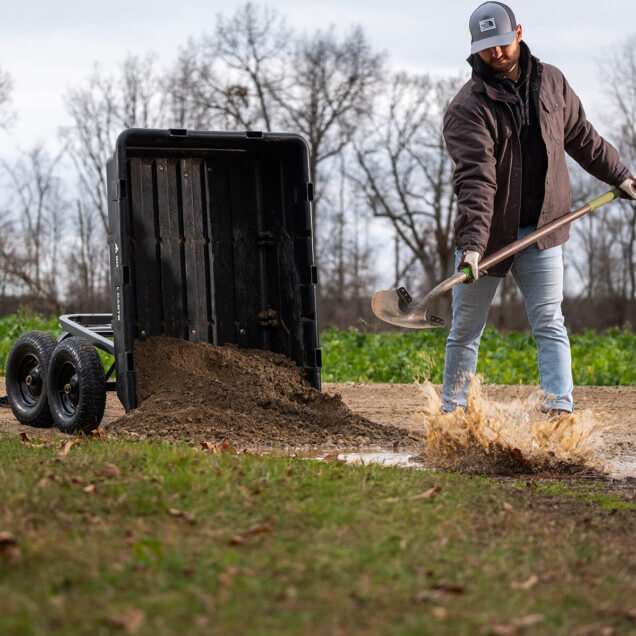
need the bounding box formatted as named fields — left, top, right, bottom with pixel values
left=0, top=312, right=636, bottom=386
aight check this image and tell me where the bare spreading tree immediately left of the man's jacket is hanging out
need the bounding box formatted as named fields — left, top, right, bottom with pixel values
left=356, top=73, right=461, bottom=292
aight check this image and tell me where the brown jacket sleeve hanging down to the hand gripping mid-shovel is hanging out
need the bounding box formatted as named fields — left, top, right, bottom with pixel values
left=444, top=107, right=497, bottom=256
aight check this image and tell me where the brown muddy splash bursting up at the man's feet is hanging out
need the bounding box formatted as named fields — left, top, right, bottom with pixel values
left=422, top=378, right=602, bottom=474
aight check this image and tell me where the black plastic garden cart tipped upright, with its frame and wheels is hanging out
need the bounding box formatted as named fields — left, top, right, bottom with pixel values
left=6, top=129, right=321, bottom=432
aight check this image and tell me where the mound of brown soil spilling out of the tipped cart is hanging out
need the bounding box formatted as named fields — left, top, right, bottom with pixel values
left=106, top=337, right=413, bottom=448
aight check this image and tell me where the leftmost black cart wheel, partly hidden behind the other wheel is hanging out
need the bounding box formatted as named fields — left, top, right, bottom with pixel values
left=6, top=331, right=57, bottom=428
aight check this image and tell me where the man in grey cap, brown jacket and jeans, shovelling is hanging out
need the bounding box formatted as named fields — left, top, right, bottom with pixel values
left=442, top=2, right=636, bottom=413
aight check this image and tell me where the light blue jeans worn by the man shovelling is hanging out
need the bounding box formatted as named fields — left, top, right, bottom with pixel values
left=442, top=227, right=573, bottom=411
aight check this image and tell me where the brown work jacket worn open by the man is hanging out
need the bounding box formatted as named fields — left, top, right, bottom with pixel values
left=444, top=48, right=630, bottom=276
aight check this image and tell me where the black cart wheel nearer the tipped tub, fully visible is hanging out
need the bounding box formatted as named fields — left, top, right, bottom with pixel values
left=48, top=337, right=106, bottom=433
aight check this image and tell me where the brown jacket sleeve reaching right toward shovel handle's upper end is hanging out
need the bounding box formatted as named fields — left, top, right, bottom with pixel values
left=563, top=77, right=630, bottom=186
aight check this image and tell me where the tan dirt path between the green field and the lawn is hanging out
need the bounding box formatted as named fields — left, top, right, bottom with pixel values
left=0, top=377, right=636, bottom=480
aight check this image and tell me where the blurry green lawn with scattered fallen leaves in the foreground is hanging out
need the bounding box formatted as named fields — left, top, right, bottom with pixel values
left=0, top=437, right=634, bottom=634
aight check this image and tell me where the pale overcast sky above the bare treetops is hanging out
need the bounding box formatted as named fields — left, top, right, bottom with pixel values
left=0, top=0, right=636, bottom=157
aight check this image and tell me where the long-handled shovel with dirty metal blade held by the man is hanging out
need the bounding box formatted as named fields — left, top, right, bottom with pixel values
left=371, top=188, right=623, bottom=329
